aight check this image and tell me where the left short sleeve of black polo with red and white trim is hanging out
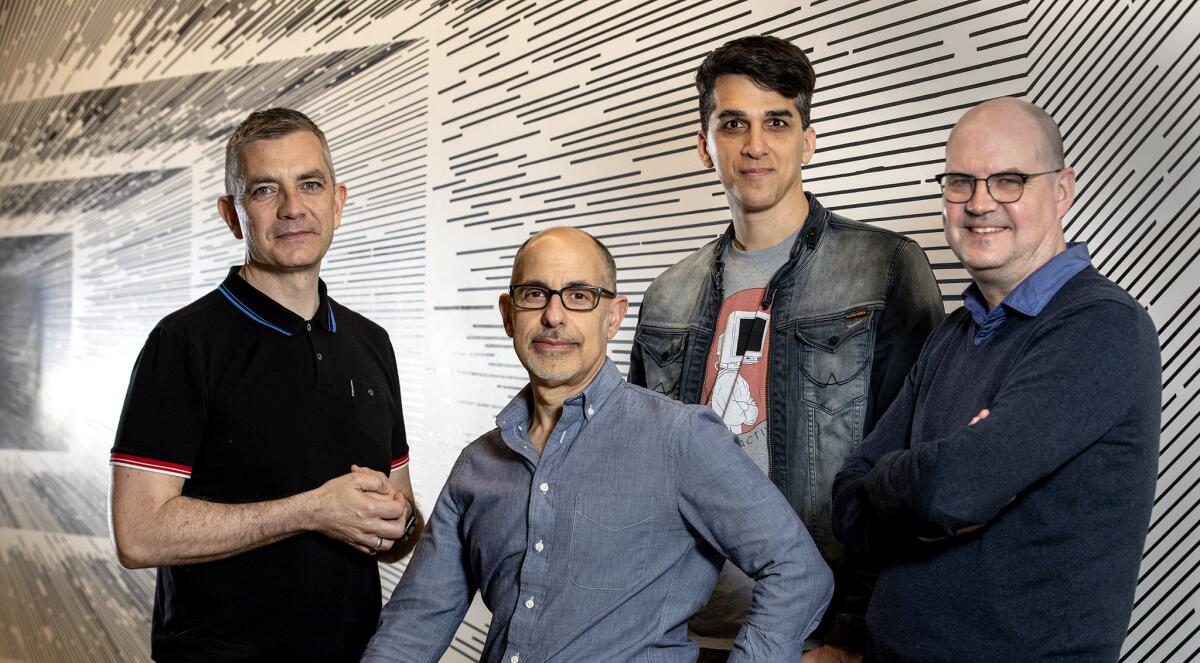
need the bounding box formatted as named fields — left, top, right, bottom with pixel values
left=109, top=327, right=208, bottom=479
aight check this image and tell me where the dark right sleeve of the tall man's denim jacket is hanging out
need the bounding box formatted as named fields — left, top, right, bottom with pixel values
left=863, top=241, right=946, bottom=436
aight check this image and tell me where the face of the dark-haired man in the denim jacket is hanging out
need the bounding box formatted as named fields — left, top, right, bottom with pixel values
left=697, top=74, right=816, bottom=214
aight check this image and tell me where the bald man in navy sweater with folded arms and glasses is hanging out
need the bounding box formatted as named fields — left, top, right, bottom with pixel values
left=833, top=98, right=1162, bottom=662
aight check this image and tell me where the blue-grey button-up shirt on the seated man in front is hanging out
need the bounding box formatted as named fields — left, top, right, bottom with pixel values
left=364, top=362, right=833, bottom=663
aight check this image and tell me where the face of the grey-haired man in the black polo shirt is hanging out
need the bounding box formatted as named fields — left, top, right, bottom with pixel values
left=217, top=131, right=346, bottom=271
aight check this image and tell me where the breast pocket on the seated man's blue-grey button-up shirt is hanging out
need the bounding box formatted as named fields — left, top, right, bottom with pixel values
left=568, top=494, right=654, bottom=591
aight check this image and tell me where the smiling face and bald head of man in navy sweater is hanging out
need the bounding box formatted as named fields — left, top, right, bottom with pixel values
left=942, top=98, right=1075, bottom=306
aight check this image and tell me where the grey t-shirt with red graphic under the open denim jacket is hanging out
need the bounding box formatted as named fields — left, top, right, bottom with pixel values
left=688, top=229, right=799, bottom=650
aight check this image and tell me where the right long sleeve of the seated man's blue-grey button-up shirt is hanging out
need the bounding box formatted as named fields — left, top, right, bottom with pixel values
left=672, top=407, right=833, bottom=663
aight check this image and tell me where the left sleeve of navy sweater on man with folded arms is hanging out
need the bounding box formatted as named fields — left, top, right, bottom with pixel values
left=833, top=366, right=920, bottom=563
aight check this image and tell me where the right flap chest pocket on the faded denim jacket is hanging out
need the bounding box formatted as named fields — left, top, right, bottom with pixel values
left=796, top=310, right=872, bottom=412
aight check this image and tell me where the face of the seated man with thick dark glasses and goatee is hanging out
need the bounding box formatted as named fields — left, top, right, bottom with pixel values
left=499, top=228, right=629, bottom=393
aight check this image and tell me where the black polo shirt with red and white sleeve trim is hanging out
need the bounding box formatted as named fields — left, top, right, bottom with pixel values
left=112, top=267, right=408, bottom=661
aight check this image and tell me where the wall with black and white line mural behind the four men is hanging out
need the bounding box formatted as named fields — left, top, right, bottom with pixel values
left=0, top=0, right=1200, bottom=661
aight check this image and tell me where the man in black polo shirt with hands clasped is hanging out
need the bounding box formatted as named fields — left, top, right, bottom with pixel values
left=112, top=108, right=420, bottom=661
